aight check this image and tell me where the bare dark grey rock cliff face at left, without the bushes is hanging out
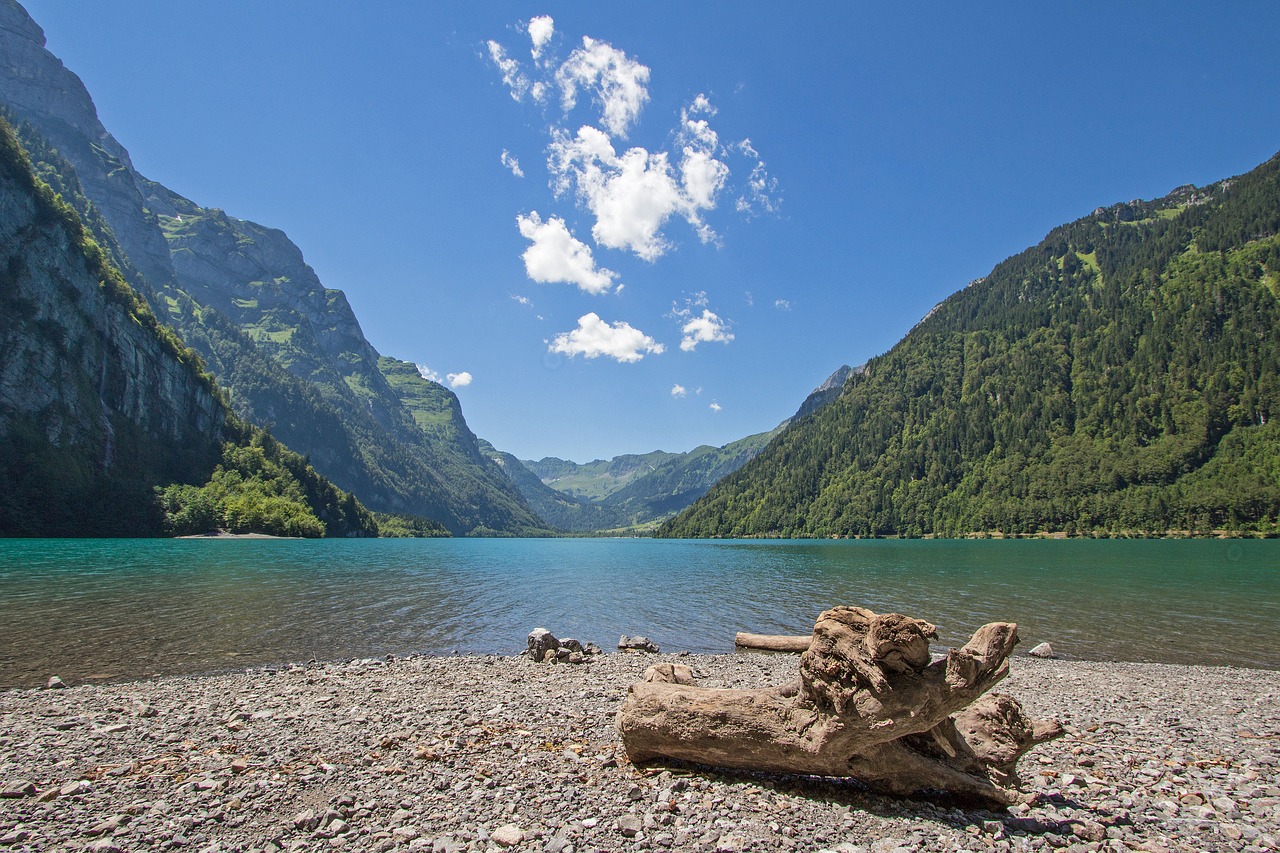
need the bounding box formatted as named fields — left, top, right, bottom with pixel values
left=0, top=124, right=224, bottom=535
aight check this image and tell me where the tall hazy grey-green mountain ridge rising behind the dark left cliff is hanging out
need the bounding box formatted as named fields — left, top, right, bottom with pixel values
left=0, top=0, right=545, bottom=534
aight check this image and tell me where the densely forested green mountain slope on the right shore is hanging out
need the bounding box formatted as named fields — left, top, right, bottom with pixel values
left=659, top=156, right=1280, bottom=537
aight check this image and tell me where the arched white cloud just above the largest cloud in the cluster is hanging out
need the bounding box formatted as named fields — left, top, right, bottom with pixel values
left=556, top=36, right=649, bottom=137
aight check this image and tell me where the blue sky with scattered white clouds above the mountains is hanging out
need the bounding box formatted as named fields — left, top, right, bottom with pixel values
left=17, top=0, right=1280, bottom=462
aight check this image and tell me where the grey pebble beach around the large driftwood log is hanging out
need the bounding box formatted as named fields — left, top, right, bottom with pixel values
left=0, top=653, right=1280, bottom=853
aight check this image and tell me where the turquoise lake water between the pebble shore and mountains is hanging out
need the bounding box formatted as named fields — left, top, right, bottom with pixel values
left=0, top=539, right=1280, bottom=686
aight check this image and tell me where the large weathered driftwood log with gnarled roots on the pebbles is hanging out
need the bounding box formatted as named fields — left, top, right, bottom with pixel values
left=617, top=607, right=1062, bottom=806
